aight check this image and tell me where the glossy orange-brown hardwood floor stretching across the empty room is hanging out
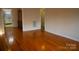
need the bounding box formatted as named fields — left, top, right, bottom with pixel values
left=6, top=28, right=79, bottom=51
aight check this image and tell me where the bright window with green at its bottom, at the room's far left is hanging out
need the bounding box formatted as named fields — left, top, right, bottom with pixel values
left=3, top=9, right=13, bottom=28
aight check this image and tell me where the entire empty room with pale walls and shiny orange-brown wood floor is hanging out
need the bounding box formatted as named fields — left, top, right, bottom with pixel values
left=0, top=8, right=79, bottom=51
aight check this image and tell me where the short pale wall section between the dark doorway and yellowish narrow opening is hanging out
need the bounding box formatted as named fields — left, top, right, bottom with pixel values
left=22, top=8, right=41, bottom=31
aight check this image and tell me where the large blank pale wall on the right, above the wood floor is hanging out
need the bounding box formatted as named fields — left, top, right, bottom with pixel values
left=45, top=8, right=79, bottom=41
